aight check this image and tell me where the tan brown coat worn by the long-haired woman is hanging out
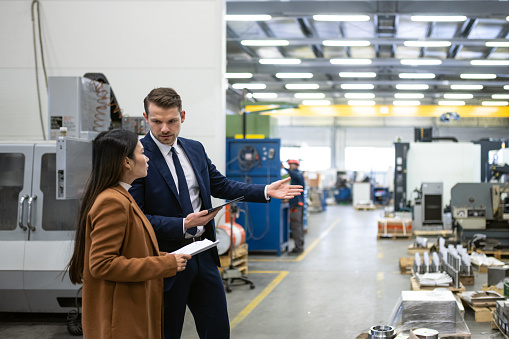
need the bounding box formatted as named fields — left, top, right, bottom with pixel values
left=82, top=185, right=177, bottom=339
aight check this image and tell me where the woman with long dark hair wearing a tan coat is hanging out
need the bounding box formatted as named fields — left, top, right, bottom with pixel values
left=68, top=130, right=191, bottom=339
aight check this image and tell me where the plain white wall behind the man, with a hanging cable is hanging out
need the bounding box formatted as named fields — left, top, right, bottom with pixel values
left=0, top=0, right=226, bottom=170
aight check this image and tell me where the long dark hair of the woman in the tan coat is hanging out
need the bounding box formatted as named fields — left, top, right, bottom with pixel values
left=67, top=129, right=138, bottom=284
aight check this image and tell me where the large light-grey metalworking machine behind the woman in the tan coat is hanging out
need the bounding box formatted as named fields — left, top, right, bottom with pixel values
left=0, top=74, right=120, bottom=313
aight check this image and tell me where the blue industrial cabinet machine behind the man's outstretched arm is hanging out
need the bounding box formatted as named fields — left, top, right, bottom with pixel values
left=226, top=139, right=290, bottom=255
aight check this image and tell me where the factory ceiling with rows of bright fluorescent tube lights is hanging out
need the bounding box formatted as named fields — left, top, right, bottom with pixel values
left=226, top=0, right=509, bottom=107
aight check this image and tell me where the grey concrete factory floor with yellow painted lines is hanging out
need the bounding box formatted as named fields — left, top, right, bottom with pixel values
left=0, top=206, right=503, bottom=339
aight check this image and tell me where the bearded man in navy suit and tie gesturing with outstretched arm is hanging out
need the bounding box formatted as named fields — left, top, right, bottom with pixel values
left=129, top=88, right=302, bottom=339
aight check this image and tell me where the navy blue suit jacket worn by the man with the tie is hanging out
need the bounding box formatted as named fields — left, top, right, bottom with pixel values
left=129, top=133, right=267, bottom=289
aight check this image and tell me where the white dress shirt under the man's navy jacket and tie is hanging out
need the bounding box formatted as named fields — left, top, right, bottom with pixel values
left=150, top=132, right=205, bottom=238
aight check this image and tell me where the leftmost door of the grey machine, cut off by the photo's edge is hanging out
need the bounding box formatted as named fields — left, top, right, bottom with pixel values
left=0, top=143, right=34, bottom=312
